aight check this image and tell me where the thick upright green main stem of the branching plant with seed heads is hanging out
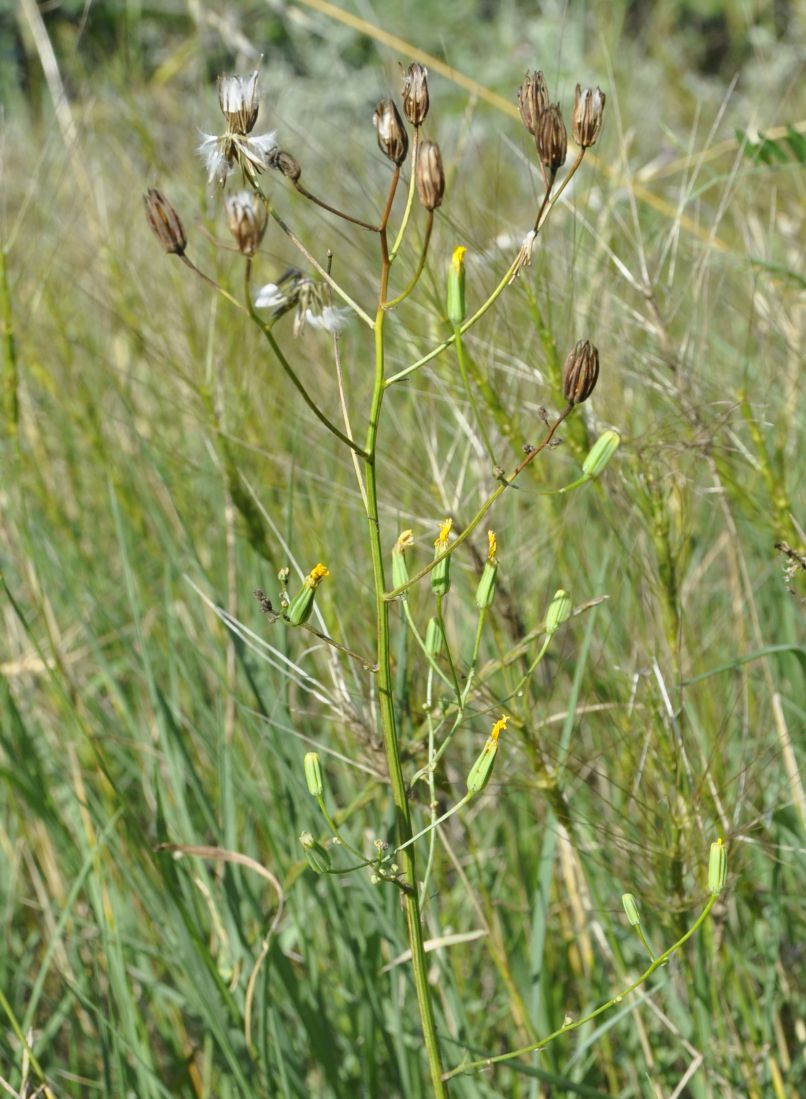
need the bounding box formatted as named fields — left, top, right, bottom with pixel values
left=364, top=226, right=448, bottom=1099
